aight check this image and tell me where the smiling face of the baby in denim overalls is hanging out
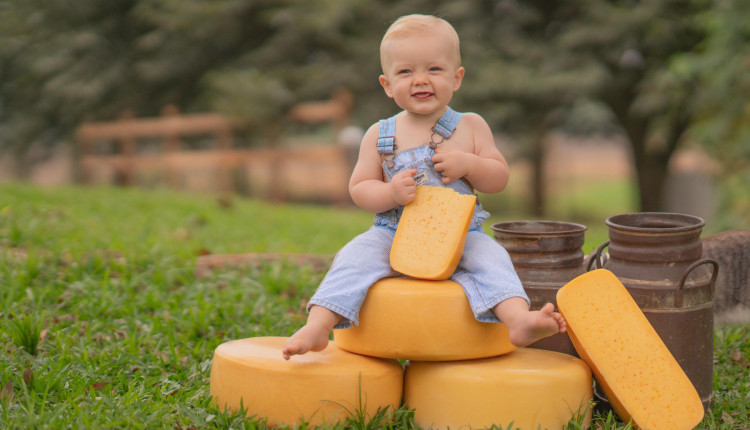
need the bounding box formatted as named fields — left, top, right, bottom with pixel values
left=380, top=32, right=464, bottom=115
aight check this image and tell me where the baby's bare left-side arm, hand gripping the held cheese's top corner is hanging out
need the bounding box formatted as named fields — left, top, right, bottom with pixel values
left=349, top=123, right=417, bottom=213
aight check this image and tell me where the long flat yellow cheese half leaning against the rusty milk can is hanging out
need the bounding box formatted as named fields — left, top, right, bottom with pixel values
left=557, top=269, right=704, bottom=430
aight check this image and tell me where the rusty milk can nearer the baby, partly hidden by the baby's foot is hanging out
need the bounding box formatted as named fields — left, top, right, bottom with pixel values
left=492, top=221, right=586, bottom=357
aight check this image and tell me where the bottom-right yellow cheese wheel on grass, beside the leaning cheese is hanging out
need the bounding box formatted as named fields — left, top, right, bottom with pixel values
left=404, top=348, right=592, bottom=430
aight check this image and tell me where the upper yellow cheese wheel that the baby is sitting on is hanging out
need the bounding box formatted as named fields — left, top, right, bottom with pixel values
left=333, top=277, right=515, bottom=361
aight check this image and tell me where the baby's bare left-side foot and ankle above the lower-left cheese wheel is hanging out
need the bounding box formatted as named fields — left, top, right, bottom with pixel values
left=281, top=306, right=341, bottom=360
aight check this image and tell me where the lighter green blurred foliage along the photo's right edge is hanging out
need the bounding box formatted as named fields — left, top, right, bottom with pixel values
left=671, top=0, right=750, bottom=229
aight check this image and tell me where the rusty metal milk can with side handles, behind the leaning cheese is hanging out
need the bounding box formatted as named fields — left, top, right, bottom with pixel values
left=587, top=212, right=719, bottom=408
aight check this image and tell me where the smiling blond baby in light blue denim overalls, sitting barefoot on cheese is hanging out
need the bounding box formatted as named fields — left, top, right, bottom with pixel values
left=282, top=15, right=566, bottom=360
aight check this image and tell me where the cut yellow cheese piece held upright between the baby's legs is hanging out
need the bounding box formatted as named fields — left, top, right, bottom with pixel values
left=390, top=185, right=477, bottom=280
